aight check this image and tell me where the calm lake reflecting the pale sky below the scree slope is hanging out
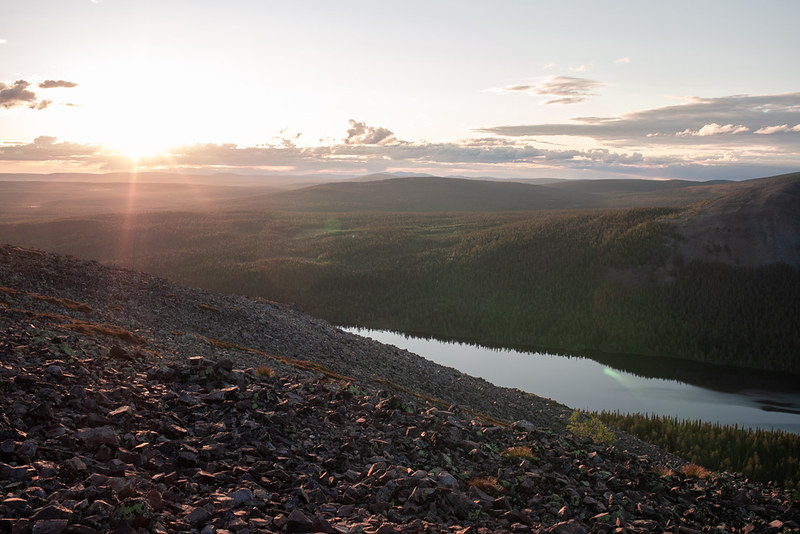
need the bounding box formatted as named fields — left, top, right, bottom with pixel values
left=346, top=328, right=800, bottom=434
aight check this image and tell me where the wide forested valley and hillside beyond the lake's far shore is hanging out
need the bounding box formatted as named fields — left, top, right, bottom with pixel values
left=0, top=208, right=800, bottom=374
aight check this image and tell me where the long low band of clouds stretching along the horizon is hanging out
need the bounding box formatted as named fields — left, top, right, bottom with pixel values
left=0, top=114, right=800, bottom=179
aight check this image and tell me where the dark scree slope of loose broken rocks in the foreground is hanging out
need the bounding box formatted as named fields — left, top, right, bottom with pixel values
left=0, top=246, right=800, bottom=534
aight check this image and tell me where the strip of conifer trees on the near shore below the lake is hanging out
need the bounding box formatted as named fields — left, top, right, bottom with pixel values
left=597, top=412, right=800, bottom=490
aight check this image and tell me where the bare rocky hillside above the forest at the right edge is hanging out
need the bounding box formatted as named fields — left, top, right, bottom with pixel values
left=675, top=173, right=800, bottom=267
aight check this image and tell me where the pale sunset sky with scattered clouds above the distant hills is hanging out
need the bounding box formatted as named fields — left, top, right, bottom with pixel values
left=0, top=0, right=800, bottom=180
